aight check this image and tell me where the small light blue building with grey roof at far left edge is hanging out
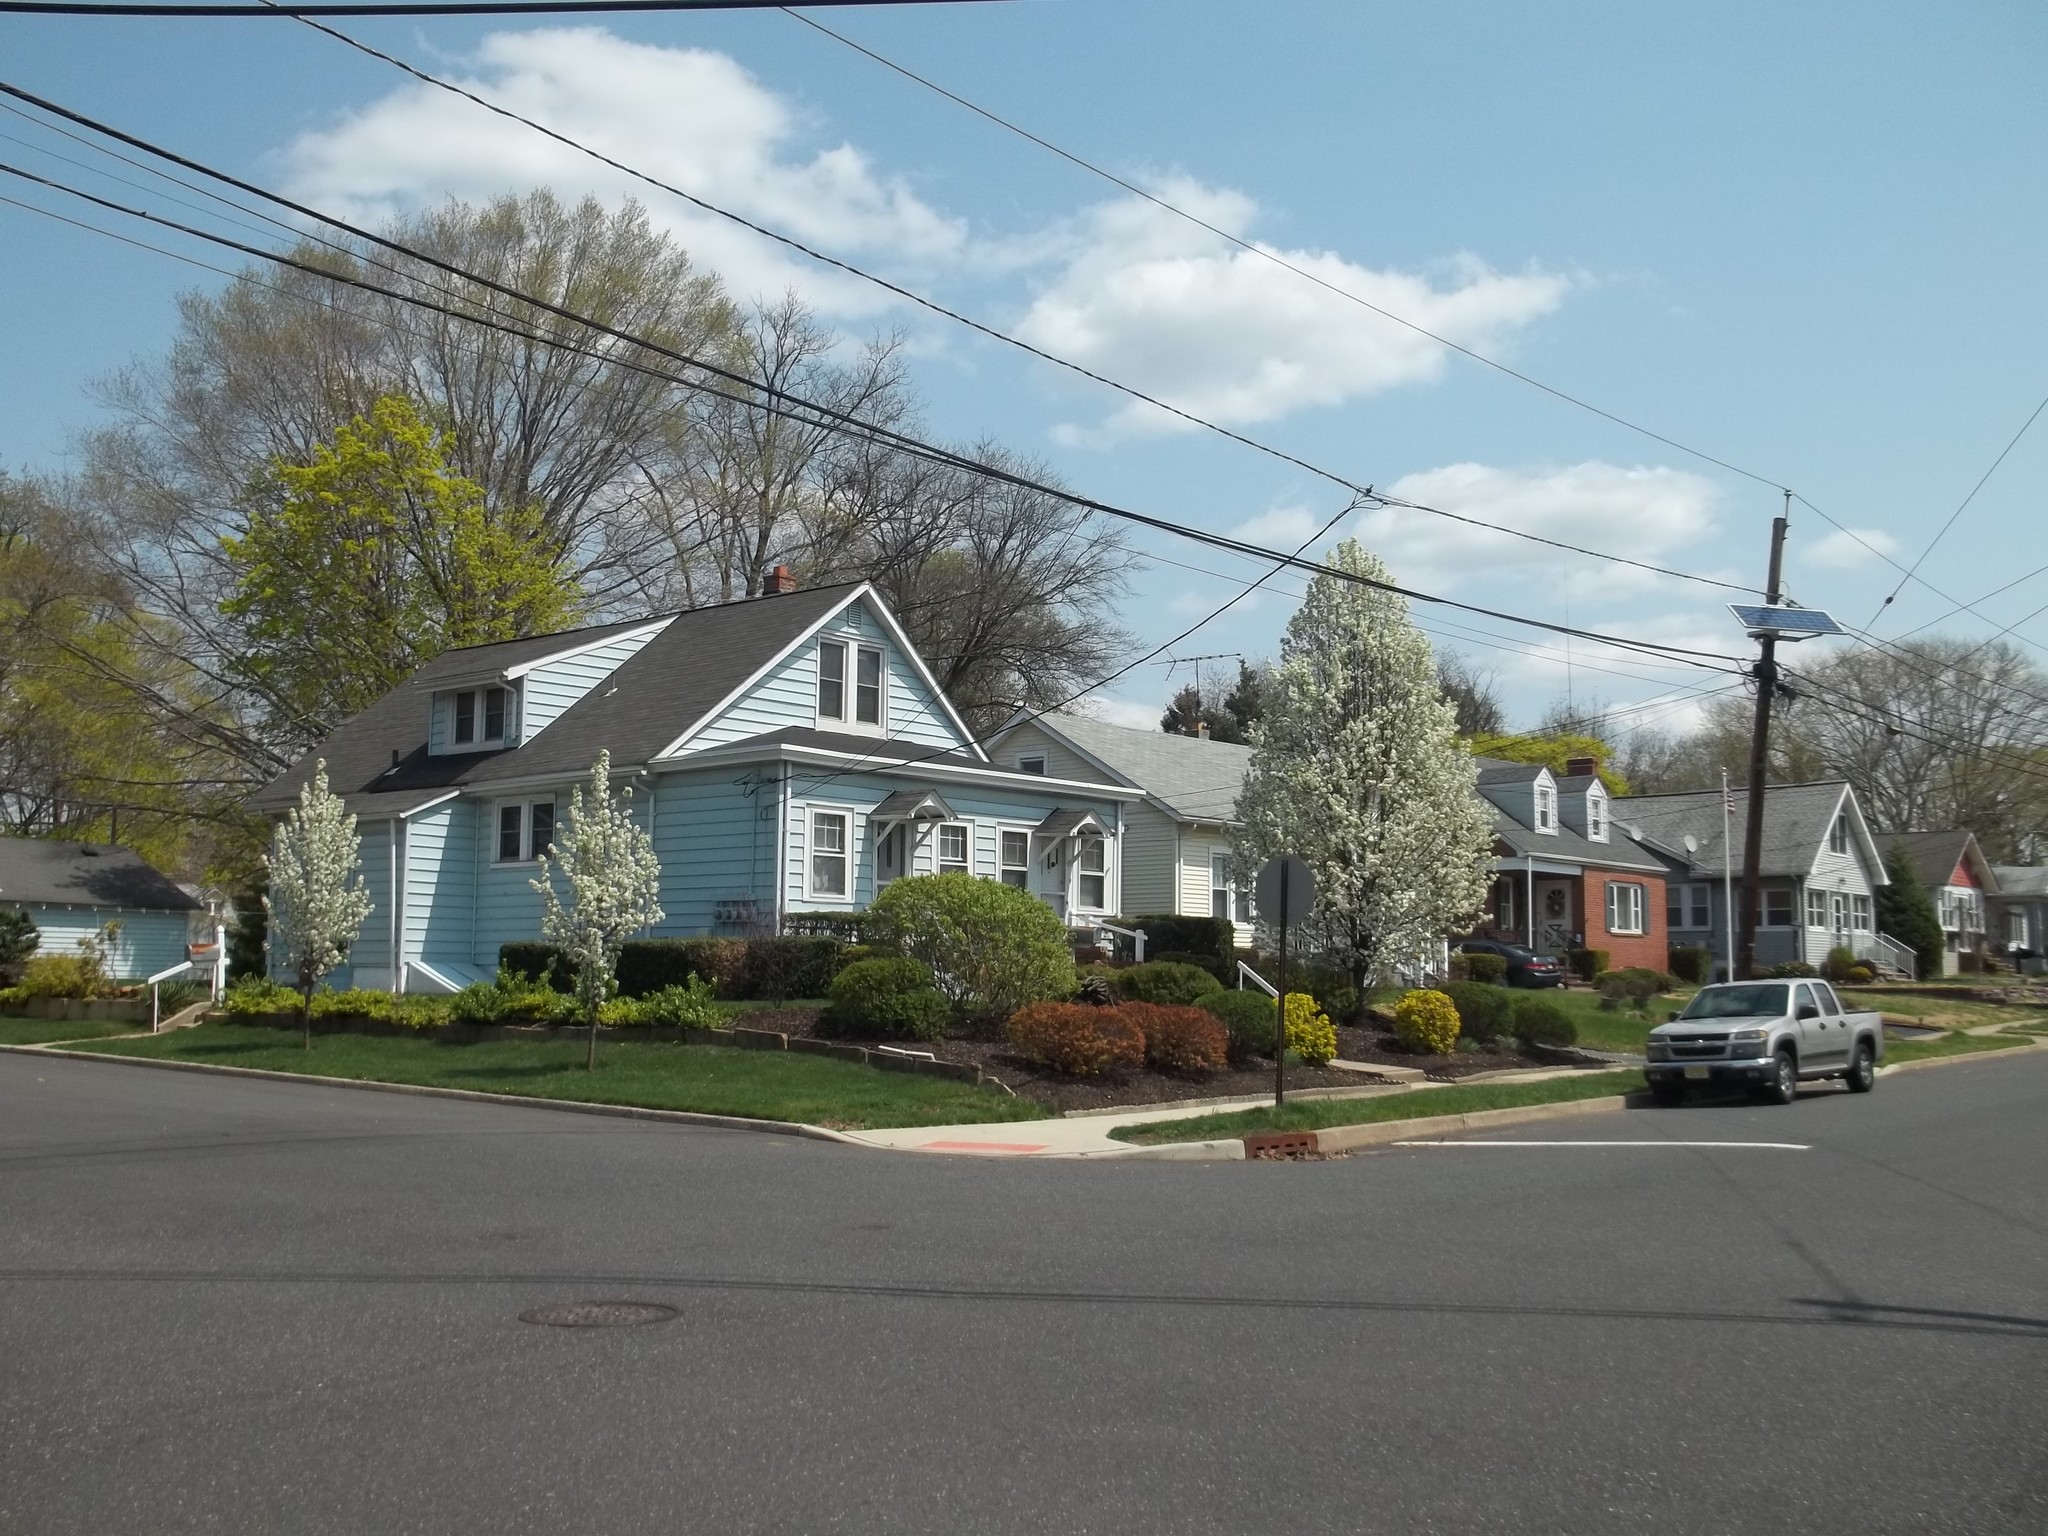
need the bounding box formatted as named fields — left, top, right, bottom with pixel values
left=0, top=838, right=211, bottom=981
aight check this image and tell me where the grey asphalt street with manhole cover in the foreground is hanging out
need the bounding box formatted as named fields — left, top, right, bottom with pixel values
left=0, top=1055, right=2048, bottom=1536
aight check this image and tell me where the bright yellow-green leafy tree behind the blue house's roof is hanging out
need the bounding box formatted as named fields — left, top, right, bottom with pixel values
left=221, top=395, right=582, bottom=733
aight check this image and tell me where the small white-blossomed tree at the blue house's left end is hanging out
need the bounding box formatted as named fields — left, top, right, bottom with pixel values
left=262, top=760, right=371, bottom=1051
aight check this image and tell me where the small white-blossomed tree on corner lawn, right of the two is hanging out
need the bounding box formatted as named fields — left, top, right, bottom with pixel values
left=532, top=752, right=662, bottom=1067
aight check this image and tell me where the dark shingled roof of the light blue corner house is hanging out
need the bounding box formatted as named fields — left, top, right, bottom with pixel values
left=248, top=584, right=858, bottom=817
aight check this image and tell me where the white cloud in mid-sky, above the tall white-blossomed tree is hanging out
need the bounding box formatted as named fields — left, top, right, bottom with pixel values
left=1018, top=178, right=1571, bottom=442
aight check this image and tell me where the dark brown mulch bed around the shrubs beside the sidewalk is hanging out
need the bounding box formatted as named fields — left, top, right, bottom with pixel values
left=761, top=1008, right=1554, bottom=1114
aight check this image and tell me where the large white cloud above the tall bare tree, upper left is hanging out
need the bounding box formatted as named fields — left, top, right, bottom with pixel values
left=285, top=27, right=967, bottom=313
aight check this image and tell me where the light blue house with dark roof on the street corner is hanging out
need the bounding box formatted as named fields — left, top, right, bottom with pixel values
left=250, top=569, right=1139, bottom=991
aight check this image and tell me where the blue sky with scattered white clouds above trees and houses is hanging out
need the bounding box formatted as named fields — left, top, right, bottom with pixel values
left=0, top=0, right=2048, bottom=741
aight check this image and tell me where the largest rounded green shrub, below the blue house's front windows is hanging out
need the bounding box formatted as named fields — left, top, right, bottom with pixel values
left=862, top=874, right=1075, bottom=1024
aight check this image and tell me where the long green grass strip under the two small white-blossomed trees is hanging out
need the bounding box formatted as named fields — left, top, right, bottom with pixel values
left=51, top=1024, right=1049, bottom=1130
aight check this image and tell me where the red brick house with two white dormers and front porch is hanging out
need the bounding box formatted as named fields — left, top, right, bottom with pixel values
left=1479, top=758, right=1669, bottom=971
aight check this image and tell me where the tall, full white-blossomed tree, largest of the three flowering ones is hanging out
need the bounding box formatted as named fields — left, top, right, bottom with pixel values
left=1237, top=539, right=1493, bottom=983
